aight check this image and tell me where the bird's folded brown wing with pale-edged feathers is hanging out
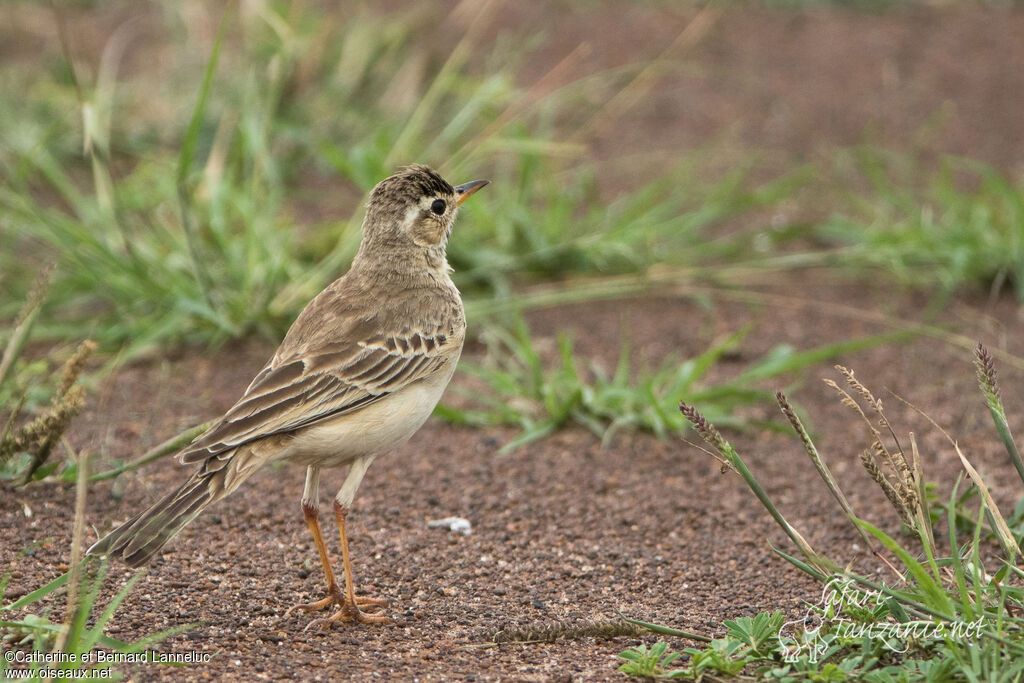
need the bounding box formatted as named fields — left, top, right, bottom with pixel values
left=180, top=331, right=453, bottom=463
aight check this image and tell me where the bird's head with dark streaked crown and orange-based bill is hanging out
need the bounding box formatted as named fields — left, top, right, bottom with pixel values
left=362, top=164, right=489, bottom=259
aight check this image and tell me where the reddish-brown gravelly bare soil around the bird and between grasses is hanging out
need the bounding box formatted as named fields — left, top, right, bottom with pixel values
left=0, top=3, right=1024, bottom=680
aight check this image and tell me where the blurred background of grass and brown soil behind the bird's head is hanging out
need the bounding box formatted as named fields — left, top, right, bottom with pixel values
left=0, top=0, right=1024, bottom=356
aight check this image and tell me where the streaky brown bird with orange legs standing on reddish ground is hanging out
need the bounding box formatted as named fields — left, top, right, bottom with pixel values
left=88, top=164, right=489, bottom=628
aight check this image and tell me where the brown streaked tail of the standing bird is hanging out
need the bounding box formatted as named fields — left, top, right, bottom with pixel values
left=88, top=446, right=268, bottom=567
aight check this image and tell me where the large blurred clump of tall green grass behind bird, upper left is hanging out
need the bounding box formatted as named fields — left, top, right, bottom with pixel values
left=0, top=4, right=540, bottom=358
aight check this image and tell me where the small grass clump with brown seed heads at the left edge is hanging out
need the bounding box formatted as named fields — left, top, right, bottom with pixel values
left=0, top=269, right=96, bottom=483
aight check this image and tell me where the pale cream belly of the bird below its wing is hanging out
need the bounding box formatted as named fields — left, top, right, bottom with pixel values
left=274, top=358, right=457, bottom=467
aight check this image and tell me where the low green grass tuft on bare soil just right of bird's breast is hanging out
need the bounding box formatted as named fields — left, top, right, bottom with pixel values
left=437, top=316, right=893, bottom=453
